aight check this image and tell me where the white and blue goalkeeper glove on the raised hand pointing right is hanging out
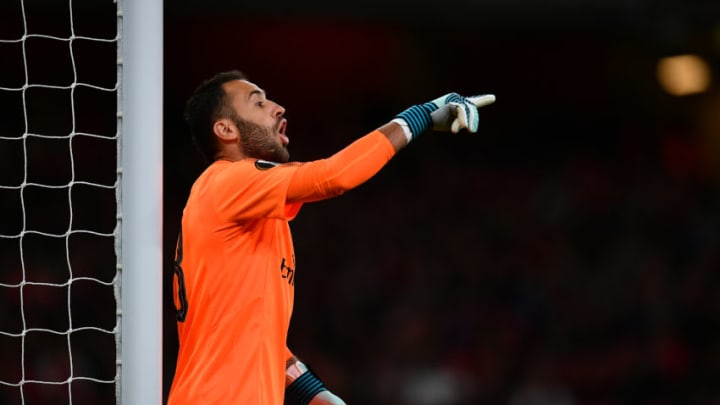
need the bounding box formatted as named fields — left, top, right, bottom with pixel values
left=393, top=93, right=495, bottom=142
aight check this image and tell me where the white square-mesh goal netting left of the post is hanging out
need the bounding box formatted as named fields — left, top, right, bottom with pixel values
left=0, top=0, right=119, bottom=404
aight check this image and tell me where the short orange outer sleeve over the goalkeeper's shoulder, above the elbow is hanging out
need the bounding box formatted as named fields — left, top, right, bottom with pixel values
left=209, top=159, right=302, bottom=222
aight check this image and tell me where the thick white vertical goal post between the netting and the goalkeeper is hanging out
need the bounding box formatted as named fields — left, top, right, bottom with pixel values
left=118, top=0, right=163, bottom=405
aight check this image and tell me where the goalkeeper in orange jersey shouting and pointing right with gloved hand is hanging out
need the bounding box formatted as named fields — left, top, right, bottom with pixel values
left=168, top=71, right=495, bottom=405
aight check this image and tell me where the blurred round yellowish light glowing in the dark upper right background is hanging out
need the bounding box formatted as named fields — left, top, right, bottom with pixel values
left=657, top=54, right=711, bottom=96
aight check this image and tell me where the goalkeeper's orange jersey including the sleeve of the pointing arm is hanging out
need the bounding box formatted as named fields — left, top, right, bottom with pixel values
left=168, top=131, right=394, bottom=405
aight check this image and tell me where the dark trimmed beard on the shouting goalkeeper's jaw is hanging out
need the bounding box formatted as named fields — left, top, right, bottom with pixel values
left=233, top=117, right=290, bottom=163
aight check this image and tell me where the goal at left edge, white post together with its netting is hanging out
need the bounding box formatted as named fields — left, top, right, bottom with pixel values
left=0, top=0, right=163, bottom=405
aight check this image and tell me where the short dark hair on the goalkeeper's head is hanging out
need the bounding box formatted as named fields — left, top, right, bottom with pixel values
left=185, top=70, right=247, bottom=162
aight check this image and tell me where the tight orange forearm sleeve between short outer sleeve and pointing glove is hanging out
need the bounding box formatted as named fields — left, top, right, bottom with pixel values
left=287, top=130, right=395, bottom=202
